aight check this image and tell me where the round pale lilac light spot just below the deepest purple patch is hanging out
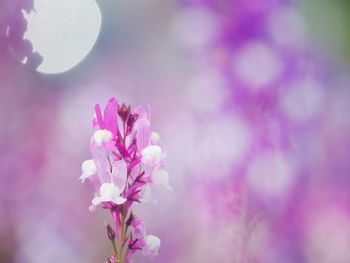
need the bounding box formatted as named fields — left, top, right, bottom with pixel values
left=233, top=42, right=283, bottom=89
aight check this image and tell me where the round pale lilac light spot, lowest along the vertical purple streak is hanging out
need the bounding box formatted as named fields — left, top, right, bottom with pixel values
left=247, top=151, right=295, bottom=196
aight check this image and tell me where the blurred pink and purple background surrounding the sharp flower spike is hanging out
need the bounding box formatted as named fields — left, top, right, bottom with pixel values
left=0, top=0, right=350, bottom=263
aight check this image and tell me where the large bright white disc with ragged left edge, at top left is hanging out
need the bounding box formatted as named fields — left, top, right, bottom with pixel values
left=24, top=0, right=102, bottom=74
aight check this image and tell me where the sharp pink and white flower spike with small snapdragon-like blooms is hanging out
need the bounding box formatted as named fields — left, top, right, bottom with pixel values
left=80, top=98, right=171, bottom=263
